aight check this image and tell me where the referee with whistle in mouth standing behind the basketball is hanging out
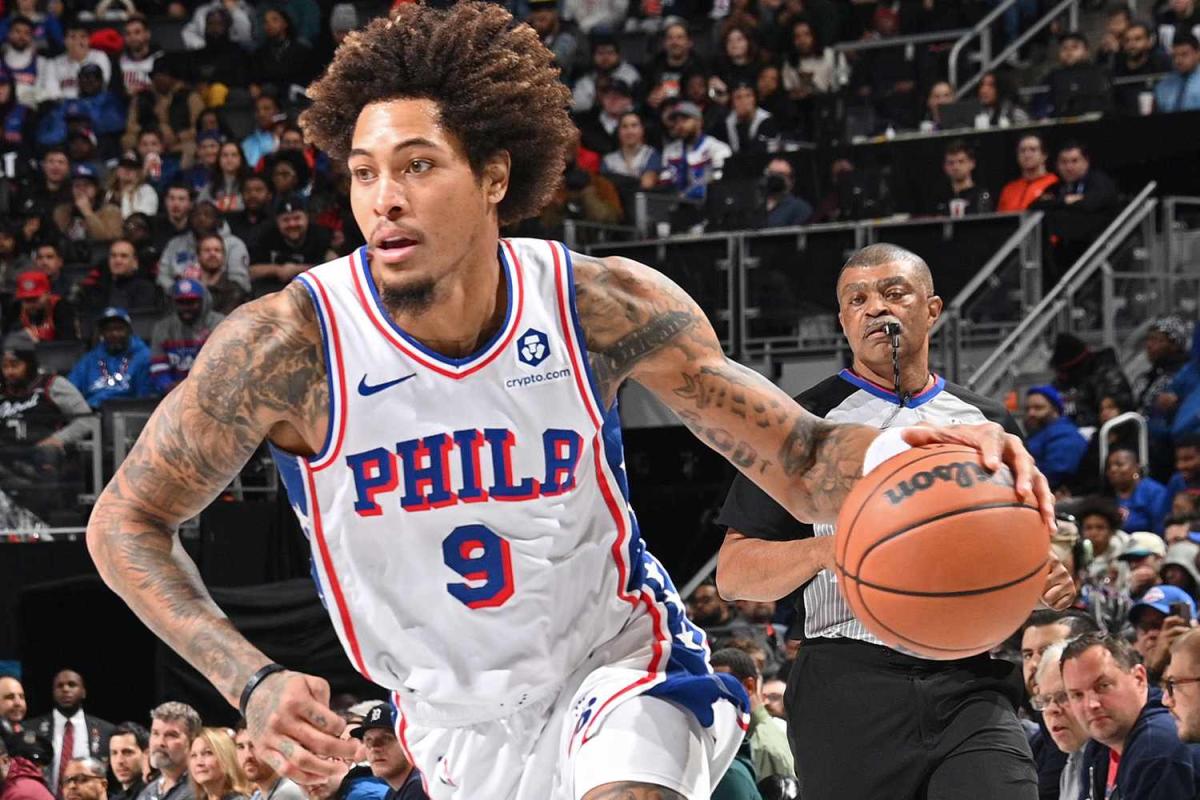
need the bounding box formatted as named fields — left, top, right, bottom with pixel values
left=716, top=243, right=1074, bottom=800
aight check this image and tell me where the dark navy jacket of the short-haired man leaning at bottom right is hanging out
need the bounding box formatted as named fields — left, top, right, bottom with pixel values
left=1081, top=688, right=1200, bottom=800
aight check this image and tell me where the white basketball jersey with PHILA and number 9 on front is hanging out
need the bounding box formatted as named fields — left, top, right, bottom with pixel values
left=274, top=239, right=686, bottom=724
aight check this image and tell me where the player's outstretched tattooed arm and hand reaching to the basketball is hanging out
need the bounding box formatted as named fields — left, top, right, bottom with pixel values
left=574, top=254, right=1054, bottom=522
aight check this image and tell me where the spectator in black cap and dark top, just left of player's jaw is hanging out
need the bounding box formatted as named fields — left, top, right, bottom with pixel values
left=250, top=193, right=337, bottom=297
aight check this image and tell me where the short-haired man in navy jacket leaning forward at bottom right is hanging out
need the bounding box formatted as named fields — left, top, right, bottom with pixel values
left=1062, top=633, right=1200, bottom=800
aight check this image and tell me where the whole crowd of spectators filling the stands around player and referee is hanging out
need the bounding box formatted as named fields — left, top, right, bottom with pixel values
left=0, top=0, right=1200, bottom=800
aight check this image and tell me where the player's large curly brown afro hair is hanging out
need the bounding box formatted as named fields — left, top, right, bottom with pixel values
left=300, top=0, right=576, bottom=224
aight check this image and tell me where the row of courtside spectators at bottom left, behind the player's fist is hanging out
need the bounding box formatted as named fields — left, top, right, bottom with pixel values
left=0, top=669, right=427, bottom=800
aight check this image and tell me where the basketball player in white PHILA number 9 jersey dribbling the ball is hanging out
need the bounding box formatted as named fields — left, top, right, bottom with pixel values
left=88, top=2, right=1052, bottom=800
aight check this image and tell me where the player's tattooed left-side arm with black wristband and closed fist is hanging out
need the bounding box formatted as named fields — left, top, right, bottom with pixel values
left=88, top=284, right=353, bottom=778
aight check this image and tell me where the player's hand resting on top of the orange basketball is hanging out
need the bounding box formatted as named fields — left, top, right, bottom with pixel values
left=904, top=422, right=1057, bottom=533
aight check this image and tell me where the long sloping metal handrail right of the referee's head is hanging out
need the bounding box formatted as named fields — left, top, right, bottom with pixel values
left=967, top=181, right=1158, bottom=393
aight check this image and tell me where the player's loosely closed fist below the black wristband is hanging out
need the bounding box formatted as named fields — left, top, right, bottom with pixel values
left=246, top=670, right=358, bottom=786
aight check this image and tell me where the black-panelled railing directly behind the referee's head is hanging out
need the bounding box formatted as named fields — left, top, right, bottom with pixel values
left=581, top=213, right=1030, bottom=369
